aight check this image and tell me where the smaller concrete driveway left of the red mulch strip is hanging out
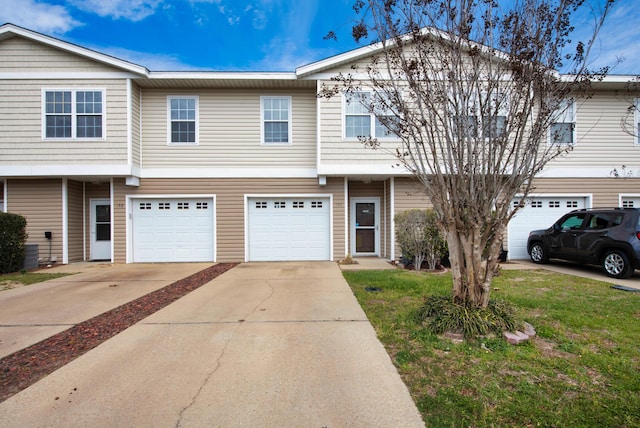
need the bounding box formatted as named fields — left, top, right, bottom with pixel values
left=0, top=263, right=211, bottom=358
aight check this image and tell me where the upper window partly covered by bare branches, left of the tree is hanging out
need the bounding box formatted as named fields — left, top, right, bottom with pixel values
left=343, top=91, right=397, bottom=139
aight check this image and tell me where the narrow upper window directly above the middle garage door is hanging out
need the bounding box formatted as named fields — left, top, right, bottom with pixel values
left=260, top=97, right=291, bottom=144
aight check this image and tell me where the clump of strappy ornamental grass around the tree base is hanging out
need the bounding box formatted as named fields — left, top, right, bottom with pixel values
left=416, top=296, right=523, bottom=338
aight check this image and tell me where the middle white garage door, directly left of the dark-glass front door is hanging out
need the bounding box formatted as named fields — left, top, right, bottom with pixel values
left=247, top=197, right=331, bottom=261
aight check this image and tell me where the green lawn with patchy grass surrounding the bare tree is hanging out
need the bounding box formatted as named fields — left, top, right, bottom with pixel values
left=344, top=270, right=640, bottom=427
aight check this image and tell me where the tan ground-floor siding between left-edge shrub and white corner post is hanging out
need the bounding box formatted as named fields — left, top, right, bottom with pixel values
left=7, top=179, right=62, bottom=263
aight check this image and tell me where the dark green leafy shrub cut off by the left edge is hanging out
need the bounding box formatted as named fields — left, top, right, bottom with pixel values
left=0, top=212, right=27, bottom=273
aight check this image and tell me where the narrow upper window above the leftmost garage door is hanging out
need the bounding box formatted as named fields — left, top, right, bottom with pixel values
left=167, top=96, right=198, bottom=144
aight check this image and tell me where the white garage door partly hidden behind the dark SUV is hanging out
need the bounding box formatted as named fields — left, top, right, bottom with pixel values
left=508, top=196, right=586, bottom=260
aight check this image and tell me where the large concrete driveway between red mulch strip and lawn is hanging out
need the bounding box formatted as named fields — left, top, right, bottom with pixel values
left=0, top=262, right=424, bottom=427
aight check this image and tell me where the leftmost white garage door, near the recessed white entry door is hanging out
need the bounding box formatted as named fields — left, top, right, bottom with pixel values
left=132, top=198, right=214, bottom=262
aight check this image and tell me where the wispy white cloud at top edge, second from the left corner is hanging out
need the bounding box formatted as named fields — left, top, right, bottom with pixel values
left=70, top=0, right=164, bottom=22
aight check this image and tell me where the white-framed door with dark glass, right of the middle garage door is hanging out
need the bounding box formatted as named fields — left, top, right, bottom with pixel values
left=351, top=198, right=380, bottom=256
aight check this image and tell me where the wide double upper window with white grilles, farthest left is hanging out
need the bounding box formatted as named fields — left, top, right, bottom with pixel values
left=43, top=89, right=105, bottom=140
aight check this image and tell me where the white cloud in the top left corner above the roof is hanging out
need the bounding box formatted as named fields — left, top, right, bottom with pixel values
left=0, top=0, right=82, bottom=35
